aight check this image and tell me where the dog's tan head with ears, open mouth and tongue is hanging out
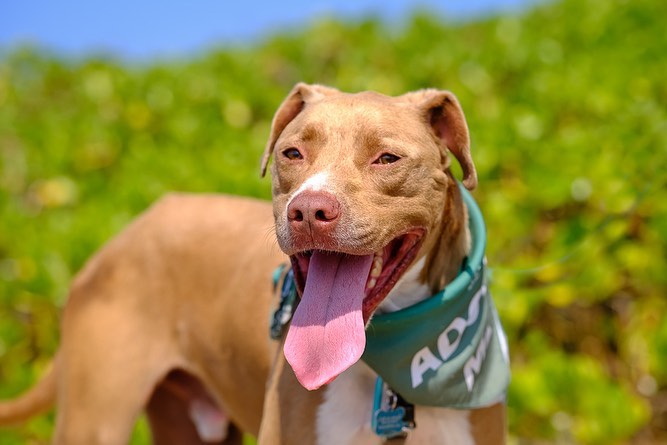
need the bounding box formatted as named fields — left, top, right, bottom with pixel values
left=262, top=84, right=477, bottom=389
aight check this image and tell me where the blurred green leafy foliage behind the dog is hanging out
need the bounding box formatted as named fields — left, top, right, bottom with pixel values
left=0, top=0, right=667, bottom=444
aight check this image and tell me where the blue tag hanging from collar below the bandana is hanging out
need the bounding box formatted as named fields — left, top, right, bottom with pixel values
left=371, top=377, right=416, bottom=440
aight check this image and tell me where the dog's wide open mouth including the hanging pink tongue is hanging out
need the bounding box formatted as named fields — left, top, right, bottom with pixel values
left=285, top=229, right=424, bottom=389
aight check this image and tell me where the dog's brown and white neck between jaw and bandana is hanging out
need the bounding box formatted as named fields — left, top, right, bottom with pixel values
left=378, top=180, right=470, bottom=313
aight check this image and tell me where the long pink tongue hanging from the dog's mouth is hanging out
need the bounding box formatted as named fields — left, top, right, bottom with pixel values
left=285, top=251, right=373, bottom=390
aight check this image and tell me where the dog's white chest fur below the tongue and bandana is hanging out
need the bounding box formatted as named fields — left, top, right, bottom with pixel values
left=316, top=362, right=474, bottom=445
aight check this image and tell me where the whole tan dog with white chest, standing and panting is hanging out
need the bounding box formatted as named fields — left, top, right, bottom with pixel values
left=0, top=84, right=505, bottom=445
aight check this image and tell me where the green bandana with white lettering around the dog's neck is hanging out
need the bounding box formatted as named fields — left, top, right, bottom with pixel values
left=362, top=187, right=510, bottom=409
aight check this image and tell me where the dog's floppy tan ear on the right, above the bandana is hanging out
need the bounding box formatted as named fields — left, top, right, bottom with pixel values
left=401, top=89, right=477, bottom=190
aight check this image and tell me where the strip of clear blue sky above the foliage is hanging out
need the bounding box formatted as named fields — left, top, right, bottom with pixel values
left=0, top=0, right=536, bottom=60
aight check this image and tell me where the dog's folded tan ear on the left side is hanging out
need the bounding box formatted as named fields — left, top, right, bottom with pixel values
left=261, top=83, right=339, bottom=177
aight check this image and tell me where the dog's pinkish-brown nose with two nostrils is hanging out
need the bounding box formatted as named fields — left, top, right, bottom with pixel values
left=287, top=191, right=340, bottom=233
